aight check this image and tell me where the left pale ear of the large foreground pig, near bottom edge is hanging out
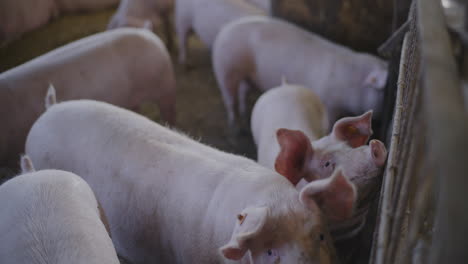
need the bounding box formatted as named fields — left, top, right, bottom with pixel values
left=219, top=207, right=268, bottom=260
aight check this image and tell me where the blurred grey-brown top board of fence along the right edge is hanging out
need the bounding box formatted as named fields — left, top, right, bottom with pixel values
left=418, top=0, right=468, bottom=264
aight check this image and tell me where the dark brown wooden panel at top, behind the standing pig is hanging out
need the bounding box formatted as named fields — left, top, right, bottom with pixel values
left=271, top=0, right=411, bottom=53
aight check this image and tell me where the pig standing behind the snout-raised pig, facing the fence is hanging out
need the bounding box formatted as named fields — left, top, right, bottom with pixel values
left=212, top=16, right=387, bottom=126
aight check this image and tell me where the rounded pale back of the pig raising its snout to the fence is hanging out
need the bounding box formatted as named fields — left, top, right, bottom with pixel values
left=251, top=84, right=329, bottom=168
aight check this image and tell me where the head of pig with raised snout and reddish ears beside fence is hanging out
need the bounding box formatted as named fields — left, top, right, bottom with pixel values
left=275, top=112, right=387, bottom=238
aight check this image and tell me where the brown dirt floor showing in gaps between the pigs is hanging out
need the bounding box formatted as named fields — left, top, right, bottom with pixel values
left=0, top=9, right=259, bottom=182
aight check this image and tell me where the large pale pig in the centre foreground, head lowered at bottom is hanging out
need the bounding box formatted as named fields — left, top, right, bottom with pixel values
left=26, top=97, right=356, bottom=264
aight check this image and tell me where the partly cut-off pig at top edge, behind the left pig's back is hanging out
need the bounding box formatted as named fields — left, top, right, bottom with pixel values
left=107, top=0, right=174, bottom=49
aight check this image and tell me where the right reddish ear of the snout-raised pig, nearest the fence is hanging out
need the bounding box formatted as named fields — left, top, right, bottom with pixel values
left=332, top=110, right=372, bottom=148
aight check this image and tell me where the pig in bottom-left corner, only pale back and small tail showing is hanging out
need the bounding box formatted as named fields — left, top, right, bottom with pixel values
left=0, top=157, right=119, bottom=264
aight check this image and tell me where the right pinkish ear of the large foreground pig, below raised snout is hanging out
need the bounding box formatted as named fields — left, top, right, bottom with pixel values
left=299, top=169, right=357, bottom=221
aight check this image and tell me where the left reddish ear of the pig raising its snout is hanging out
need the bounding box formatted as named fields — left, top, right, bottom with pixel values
left=275, top=128, right=313, bottom=185
